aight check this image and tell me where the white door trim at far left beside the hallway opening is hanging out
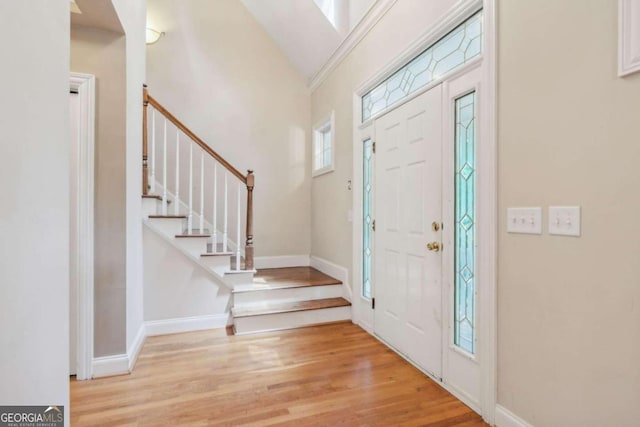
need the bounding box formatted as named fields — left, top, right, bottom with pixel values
left=69, top=73, right=95, bottom=380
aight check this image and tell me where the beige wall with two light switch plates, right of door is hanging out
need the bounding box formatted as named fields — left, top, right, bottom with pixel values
left=498, top=0, right=640, bottom=427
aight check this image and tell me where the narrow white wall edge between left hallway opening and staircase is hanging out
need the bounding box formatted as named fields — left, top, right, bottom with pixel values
left=113, top=0, right=147, bottom=362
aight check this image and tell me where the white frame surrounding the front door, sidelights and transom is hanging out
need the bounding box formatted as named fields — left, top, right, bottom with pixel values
left=352, top=0, right=498, bottom=425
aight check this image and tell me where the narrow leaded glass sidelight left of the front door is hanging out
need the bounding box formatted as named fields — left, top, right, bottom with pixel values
left=362, top=139, right=373, bottom=298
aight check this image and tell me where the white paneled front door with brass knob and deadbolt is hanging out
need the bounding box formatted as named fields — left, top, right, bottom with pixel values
left=374, top=85, right=443, bottom=378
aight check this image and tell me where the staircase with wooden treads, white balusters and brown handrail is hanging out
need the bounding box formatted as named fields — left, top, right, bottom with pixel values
left=142, top=86, right=351, bottom=334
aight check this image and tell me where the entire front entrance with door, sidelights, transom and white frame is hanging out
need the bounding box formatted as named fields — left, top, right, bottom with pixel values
left=352, top=0, right=498, bottom=424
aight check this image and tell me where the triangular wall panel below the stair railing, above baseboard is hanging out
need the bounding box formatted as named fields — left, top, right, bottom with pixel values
left=144, top=228, right=231, bottom=321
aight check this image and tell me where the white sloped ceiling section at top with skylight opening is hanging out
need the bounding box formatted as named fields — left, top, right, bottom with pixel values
left=242, top=0, right=376, bottom=80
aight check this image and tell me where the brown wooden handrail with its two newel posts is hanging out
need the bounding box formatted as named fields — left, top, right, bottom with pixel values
left=142, top=84, right=255, bottom=270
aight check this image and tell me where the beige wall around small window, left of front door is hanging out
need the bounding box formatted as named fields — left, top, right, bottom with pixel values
left=311, top=0, right=455, bottom=283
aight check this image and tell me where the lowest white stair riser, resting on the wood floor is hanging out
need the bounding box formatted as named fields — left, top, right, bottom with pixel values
left=233, top=306, right=351, bottom=334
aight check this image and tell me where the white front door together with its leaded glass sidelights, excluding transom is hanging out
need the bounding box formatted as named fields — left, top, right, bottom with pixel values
left=358, top=65, right=488, bottom=412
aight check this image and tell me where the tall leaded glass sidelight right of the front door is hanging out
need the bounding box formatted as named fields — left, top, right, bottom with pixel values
left=453, top=92, right=476, bottom=354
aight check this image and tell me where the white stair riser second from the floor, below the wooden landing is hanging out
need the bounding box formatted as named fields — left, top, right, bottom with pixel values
left=233, top=285, right=342, bottom=307
